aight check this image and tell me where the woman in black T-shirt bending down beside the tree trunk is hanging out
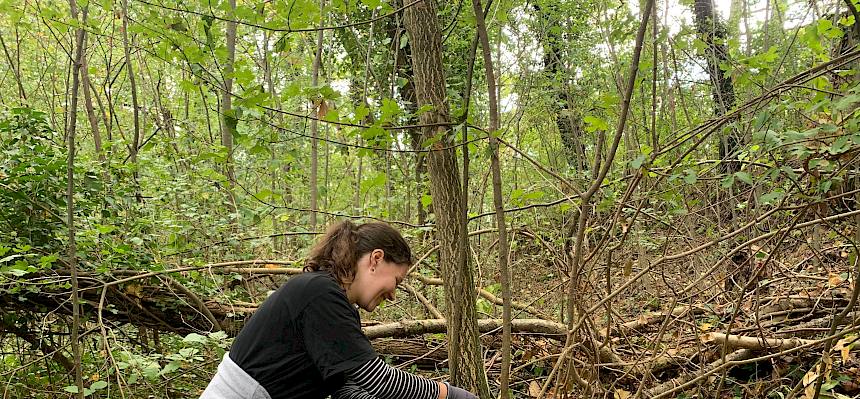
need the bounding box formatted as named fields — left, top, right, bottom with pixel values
left=201, top=221, right=477, bottom=399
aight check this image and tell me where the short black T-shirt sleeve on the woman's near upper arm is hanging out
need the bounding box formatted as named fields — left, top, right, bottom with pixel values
left=300, top=279, right=377, bottom=380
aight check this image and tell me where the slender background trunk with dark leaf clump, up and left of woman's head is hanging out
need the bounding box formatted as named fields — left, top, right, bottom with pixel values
left=218, top=0, right=239, bottom=220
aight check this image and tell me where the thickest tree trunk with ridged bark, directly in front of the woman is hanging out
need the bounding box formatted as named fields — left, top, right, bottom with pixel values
left=403, top=0, right=490, bottom=399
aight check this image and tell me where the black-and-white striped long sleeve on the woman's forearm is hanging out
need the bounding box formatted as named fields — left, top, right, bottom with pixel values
left=332, top=358, right=439, bottom=399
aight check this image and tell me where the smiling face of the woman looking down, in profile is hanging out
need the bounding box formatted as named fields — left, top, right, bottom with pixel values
left=347, top=249, right=409, bottom=312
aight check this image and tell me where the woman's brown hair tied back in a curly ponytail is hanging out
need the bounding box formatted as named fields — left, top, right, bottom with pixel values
left=304, top=220, right=412, bottom=284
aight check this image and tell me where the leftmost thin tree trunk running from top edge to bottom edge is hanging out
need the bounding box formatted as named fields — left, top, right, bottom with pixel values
left=66, top=0, right=87, bottom=399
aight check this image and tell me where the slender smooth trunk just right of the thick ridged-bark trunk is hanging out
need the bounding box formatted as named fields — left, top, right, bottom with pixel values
left=472, top=0, right=511, bottom=399
